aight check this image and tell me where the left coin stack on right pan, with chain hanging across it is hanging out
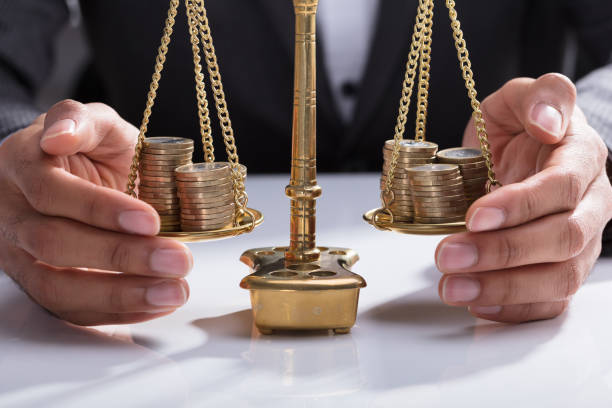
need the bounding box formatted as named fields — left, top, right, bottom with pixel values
left=380, top=139, right=438, bottom=222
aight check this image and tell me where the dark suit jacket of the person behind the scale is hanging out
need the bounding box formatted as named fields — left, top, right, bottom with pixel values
left=0, top=0, right=612, bottom=253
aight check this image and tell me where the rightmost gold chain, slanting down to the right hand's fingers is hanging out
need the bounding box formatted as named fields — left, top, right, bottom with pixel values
left=446, top=0, right=501, bottom=192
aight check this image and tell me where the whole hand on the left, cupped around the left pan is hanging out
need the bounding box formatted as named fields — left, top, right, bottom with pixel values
left=0, top=101, right=193, bottom=325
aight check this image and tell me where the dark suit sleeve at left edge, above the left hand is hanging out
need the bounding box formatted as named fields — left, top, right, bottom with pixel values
left=0, top=0, right=68, bottom=140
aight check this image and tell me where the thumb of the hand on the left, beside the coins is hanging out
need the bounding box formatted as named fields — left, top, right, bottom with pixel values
left=40, top=100, right=133, bottom=156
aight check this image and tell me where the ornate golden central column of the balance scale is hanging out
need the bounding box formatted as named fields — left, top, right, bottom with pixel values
left=285, top=0, right=321, bottom=262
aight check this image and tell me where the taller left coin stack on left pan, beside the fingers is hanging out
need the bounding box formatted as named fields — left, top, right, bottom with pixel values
left=138, top=137, right=193, bottom=232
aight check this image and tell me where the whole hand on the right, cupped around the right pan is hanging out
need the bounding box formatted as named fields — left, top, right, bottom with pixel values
left=436, top=74, right=612, bottom=322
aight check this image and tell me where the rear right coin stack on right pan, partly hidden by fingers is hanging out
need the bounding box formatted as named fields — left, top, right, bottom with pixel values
left=437, top=147, right=489, bottom=207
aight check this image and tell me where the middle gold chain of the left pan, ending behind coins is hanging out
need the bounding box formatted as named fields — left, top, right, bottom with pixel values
left=185, top=0, right=215, bottom=163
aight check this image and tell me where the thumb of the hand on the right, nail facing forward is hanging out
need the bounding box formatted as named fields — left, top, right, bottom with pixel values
left=483, top=74, right=576, bottom=144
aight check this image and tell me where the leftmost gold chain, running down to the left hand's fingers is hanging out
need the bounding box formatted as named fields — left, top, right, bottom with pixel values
left=126, top=0, right=179, bottom=197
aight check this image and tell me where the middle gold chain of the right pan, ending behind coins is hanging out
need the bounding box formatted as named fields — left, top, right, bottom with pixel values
left=414, top=0, right=434, bottom=142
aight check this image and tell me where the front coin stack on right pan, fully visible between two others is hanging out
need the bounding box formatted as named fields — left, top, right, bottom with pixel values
left=407, top=163, right=467, bottom=224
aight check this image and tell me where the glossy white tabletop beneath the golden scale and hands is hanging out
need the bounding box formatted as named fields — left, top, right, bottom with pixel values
left=0, top=175, right=612, bottom=408
